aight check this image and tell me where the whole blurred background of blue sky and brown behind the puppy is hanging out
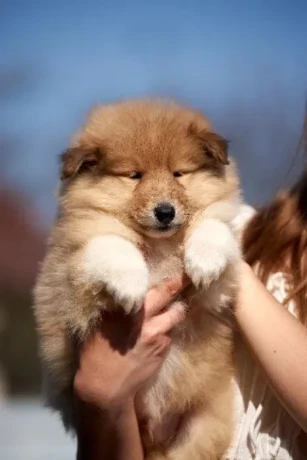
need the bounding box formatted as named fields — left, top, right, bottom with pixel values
left=0, top=0, right=307, bottom=460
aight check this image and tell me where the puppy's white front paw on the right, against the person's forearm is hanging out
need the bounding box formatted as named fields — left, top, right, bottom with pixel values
left=185, top=219, right=240, bottom=288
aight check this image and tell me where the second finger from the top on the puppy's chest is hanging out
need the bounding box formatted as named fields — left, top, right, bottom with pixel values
left=144, top=302, right=186, bottom=338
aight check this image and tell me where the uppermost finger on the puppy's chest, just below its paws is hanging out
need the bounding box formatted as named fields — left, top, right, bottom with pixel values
left=144, top=274, right=189, bottom=318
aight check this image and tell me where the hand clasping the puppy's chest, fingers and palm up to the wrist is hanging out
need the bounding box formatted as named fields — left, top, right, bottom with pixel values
left=74, top=276, right=188, bottom=408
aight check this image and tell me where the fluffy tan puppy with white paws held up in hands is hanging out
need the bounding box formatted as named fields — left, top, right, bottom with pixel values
left=34, top=100, right=240, bottom=460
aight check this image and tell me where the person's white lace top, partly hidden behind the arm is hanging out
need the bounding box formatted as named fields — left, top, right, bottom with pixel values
left=225, top=205, right=306, bottom=460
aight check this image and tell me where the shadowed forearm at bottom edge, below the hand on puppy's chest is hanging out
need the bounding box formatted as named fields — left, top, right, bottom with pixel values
left=77, top=402, right=144, bottom=460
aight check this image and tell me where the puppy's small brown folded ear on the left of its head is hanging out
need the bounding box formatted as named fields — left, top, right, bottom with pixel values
left=61, top=147, right=101, bottom=180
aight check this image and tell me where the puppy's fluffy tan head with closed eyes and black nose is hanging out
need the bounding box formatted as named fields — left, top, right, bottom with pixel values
left=62, top=101, right=237, bottom=237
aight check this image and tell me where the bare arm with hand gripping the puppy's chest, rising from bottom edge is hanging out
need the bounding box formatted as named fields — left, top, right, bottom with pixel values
left=74, top=277, right=186, bottom=460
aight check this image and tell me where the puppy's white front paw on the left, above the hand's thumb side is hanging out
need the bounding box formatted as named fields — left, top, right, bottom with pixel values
left=84, top=235, right=149, bottom=313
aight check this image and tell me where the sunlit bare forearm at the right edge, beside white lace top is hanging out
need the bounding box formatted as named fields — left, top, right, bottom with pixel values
left=236, top=266, right=307, bottom=431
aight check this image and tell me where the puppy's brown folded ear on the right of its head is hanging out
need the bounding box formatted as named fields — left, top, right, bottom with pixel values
left=189, top=125, right=229, bottom=165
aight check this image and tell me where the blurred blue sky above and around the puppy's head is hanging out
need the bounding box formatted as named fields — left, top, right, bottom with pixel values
left=0, top=0, right=307, bottom=220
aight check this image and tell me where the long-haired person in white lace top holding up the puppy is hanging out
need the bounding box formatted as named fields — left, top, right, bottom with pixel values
left=74, top=154, right=307, bottom=460
